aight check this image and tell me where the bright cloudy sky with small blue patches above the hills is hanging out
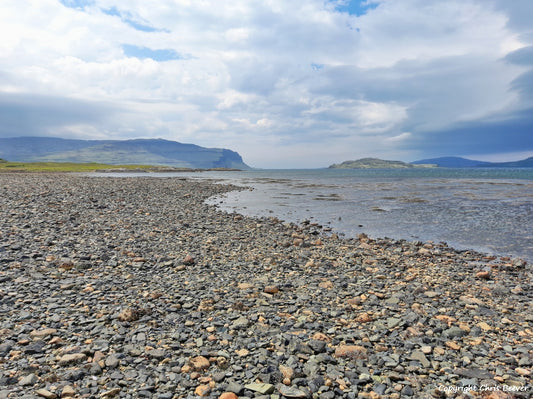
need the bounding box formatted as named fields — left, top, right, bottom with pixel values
left=0, top=0, right=533, bottom=168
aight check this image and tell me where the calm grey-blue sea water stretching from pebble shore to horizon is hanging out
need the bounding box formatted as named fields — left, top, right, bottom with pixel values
left=95, top=168, right=533, bottom=262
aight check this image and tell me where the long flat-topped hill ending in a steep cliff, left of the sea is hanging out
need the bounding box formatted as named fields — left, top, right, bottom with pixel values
left=0, top=137, right=250, bottom=169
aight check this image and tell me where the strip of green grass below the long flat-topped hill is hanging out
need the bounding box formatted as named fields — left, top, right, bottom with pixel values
left=0, top=159, right=166, bottom=173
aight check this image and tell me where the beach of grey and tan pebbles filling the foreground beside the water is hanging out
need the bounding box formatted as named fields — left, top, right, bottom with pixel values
left=0, top=173, right=533, bottom=399
